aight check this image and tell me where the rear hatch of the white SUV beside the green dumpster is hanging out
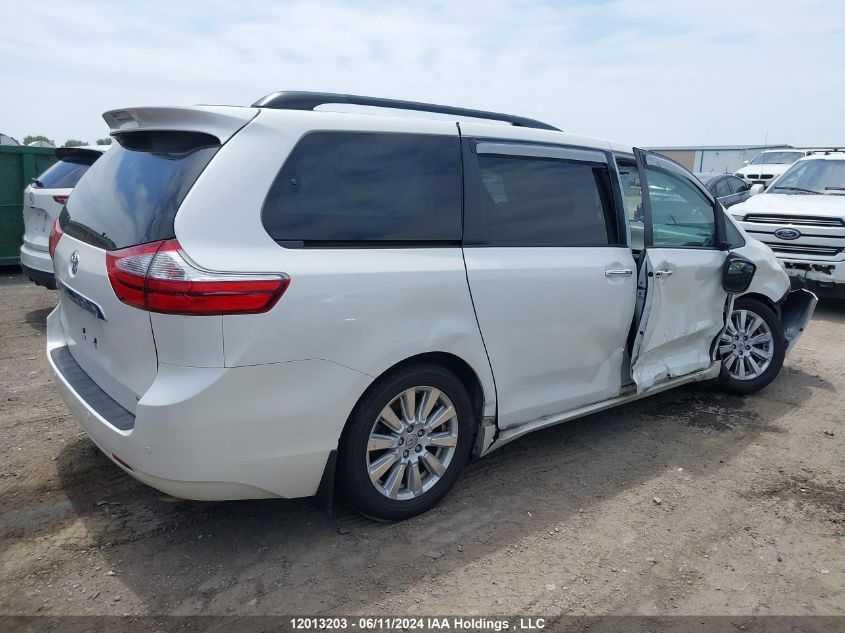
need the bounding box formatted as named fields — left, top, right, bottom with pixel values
left=23, top=147, right=102, bottom=252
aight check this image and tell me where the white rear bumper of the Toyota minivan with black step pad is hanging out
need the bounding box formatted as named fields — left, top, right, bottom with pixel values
left=47, top=306, right=372, bottom=500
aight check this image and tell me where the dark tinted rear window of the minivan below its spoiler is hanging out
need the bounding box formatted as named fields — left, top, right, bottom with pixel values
left=60, top=132, right=219, bottom=250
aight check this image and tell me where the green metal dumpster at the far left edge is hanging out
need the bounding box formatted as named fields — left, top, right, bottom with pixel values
left=0, top=145, right=58, bottom=266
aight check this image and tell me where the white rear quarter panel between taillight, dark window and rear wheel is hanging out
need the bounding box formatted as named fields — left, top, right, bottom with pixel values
left=218, top=246, right=496, bottom=415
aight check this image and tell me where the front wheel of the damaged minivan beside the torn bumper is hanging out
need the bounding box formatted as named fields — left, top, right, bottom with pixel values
left=719, top=297, right=786, bottom=394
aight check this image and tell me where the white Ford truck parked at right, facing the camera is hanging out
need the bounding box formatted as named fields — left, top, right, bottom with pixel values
left=731, top=152, right=845, bottom=296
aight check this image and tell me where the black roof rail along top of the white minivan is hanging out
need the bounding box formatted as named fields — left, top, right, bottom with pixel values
left=252, top=91, right=560, bottom=132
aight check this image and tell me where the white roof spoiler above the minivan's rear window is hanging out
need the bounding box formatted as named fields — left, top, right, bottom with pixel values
left=103, top=106, right=259, bottom=143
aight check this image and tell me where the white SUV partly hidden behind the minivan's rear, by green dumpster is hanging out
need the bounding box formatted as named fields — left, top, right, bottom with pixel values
left=21, top=146, right=108, bottom=289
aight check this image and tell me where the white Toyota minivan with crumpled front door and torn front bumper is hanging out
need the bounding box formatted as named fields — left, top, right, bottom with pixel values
left=47, top=92, right=815, bottom=520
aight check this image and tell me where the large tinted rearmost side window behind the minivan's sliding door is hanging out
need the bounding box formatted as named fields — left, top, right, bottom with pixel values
left=261, top=132, right=462, bottom=244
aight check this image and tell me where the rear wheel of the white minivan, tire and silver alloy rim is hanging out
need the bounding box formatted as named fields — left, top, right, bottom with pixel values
left=338, top=365, right=473, bottom=521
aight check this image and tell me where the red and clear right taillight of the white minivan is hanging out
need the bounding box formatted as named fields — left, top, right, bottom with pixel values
left=106, top=240, right=290, bottom=315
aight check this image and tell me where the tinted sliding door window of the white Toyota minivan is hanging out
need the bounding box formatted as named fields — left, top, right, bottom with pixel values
left=474, top=155, right=617, bottom=246
